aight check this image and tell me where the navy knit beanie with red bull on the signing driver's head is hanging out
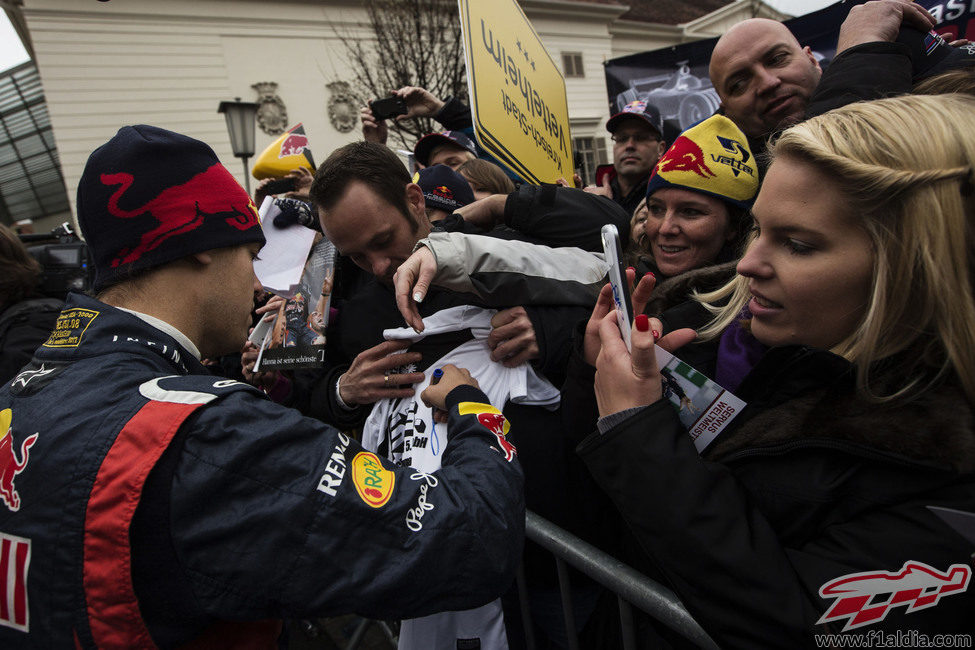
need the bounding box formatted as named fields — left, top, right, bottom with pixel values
left=78, top=124, right=264, bottom=291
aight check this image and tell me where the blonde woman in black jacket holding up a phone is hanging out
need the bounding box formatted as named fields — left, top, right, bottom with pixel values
left=579, top=96, right=975, bottom=648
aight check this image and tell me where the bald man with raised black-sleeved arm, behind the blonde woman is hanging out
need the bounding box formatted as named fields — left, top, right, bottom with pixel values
left=709, top=0, right=935, bottom=139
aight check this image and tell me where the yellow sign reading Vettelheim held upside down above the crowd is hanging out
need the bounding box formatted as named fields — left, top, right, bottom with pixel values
left=458, top=0, right=575, bottom=185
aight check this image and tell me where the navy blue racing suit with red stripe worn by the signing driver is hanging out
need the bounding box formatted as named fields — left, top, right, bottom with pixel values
left=0, top=295, right=524, bottom=648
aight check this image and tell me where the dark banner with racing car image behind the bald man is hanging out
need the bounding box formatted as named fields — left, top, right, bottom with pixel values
left=604, top=0, right=975, bottom=142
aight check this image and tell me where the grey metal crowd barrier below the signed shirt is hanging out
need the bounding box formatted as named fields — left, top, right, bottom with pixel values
left=523, top=511, right=718, bottom=650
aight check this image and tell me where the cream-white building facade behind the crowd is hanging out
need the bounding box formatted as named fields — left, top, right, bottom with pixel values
left=5, top=0, right=785, bottom=220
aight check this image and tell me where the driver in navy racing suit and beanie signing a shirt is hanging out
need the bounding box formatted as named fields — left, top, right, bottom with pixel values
left=0, top=126, right=525, bottom=648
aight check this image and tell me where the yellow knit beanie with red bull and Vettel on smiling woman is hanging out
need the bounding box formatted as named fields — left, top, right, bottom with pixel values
left=647, top=115, right=759, bottom=208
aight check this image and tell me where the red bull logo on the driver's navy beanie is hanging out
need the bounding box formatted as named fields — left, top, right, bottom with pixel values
left=101, top=163, right=259, bottom=267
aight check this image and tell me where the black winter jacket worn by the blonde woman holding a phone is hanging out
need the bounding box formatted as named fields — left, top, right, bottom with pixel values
left=578, top=308, right=975, bottom=648
